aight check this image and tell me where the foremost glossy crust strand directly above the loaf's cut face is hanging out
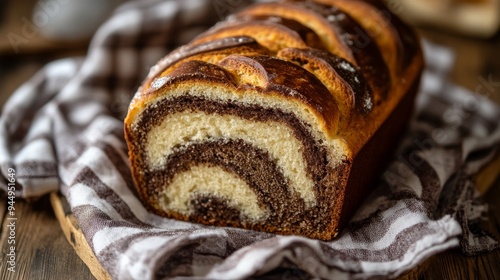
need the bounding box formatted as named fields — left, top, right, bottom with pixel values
left=130, top=55, right=340, bottom=137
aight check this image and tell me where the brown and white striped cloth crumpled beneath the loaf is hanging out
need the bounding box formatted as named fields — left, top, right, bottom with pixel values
left=0, top=0, right=500, bottom=279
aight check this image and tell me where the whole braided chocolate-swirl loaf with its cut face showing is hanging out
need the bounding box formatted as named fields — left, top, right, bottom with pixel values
left=125, top=0, right=423, bottom=240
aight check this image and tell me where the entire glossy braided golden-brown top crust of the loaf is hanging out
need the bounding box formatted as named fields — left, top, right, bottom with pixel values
left=126, top=0, right=422, bottom=156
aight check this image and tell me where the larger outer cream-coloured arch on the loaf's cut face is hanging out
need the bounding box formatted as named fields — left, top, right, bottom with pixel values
left=146, top=111, right=316, bottom=207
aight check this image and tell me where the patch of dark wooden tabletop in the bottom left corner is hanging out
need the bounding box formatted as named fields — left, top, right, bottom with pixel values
left=0, top=196, right=94, bottom=280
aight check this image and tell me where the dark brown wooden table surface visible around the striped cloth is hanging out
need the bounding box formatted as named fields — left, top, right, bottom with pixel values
left=0, top=1, right=500, bottom=280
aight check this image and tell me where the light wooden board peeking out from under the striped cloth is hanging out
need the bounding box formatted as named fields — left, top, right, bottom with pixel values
left=50, top=155, right=500, bottom=280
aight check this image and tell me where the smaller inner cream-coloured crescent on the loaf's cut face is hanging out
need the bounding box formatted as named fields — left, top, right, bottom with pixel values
left=159, top=165, right=269, bottom=221
